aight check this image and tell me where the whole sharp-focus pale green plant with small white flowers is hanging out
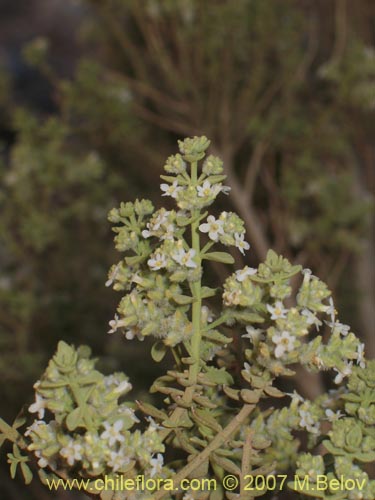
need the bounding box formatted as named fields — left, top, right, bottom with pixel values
left=0, top=137, right=375, bottom=500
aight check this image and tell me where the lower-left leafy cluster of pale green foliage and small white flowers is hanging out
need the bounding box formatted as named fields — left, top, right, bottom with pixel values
left=24, top=343, right=164, bottom=477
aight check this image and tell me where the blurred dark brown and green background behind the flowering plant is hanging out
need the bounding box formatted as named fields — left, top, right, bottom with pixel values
left=0, top=0, right=375, bottom=500
